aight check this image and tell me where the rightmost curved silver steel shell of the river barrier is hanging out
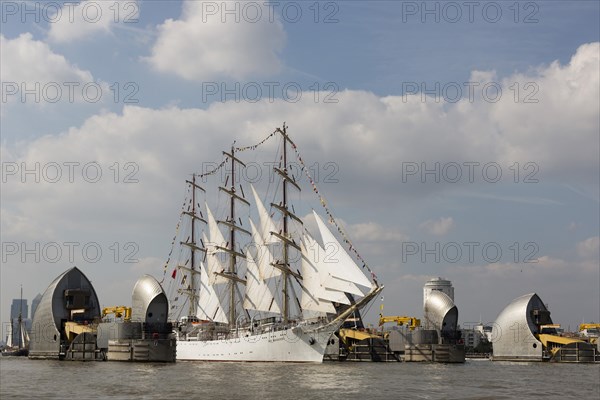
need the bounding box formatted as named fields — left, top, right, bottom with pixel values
left=492, top=293, right=552, bottom=361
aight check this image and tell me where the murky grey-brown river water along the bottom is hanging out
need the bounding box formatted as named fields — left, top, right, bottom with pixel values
left=0, top=357, right=600, bottom=400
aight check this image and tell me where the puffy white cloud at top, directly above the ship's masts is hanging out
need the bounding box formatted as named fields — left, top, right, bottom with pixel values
left=146, top=1, right=286, bottom=81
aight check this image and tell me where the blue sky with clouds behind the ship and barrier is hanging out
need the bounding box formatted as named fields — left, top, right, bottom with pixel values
left=0, top=0, right=600, bottom=336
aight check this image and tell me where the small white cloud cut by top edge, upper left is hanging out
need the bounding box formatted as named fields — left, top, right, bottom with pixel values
left=48, top=0, right=139, bottom=43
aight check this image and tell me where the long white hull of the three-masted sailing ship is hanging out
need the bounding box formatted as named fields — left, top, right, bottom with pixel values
left=177, top=322, right=341, bottom=363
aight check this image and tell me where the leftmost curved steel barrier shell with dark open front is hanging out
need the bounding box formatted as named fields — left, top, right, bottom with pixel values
left=29, top=267, right=100, bottom=358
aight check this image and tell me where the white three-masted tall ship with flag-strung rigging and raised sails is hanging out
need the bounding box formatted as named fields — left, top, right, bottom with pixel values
left=163, top=123, right=383, bottom=363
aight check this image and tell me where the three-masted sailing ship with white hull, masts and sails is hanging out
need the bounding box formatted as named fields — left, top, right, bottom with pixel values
left=169, top=126, right=382, bottom=362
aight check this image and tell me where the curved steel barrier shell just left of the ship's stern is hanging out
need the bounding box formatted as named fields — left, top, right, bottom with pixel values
left=131, top=275, right=169, bottom=323
